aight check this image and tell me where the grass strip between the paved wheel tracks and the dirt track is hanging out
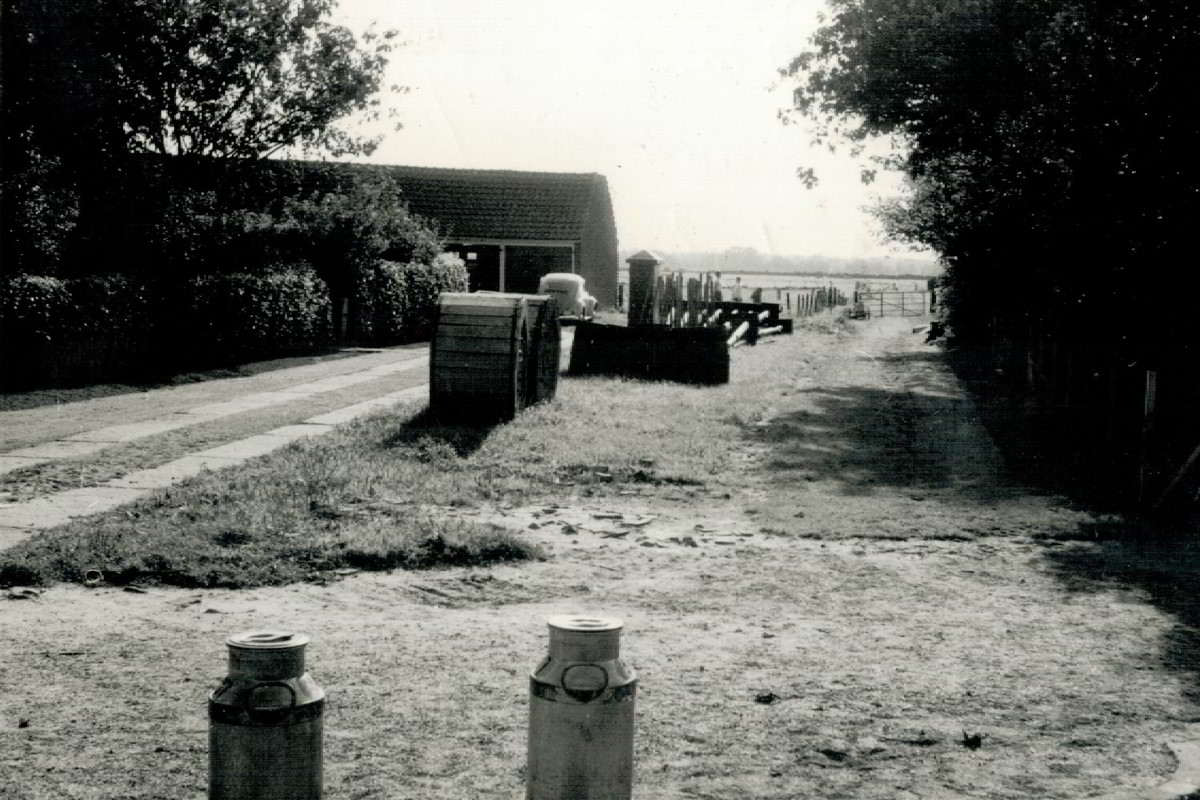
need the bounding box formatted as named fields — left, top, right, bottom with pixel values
left=0, top=321, right=835, bottom=588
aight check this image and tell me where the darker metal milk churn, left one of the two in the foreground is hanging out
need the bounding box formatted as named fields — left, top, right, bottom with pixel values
left=209, top=631, right=325, bottom=800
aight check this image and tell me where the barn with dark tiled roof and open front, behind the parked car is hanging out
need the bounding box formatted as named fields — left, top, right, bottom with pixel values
left=377, top=166, right=618, bottom=306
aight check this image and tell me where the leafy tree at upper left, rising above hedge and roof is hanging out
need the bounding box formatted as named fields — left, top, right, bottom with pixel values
left=0, top=0, right=398, bottom=270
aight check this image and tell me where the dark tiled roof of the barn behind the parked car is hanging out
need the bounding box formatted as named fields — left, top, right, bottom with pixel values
left=369, top=166, right=608, bottom=241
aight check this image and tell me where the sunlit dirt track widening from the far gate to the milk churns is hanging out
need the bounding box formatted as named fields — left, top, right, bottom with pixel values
left=0, top=320, right=1200, bottom=800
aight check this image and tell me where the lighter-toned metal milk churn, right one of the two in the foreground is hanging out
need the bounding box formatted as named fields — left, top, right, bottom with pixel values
left=526, top=615, right=637, bottom=800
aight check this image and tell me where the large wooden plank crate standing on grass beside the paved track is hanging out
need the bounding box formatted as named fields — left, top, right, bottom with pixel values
left=430, top=293, right=560, bottom=421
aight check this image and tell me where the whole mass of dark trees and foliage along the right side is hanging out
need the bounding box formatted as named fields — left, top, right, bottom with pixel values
left=784, top=0, right=1200, bottom=506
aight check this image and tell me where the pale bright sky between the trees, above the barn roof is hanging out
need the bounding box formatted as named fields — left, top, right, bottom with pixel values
left=335, top=0, right=912, bottom=258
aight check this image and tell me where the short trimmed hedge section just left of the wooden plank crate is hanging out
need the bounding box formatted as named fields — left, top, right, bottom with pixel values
left=354, top=253, right=467, bottom=345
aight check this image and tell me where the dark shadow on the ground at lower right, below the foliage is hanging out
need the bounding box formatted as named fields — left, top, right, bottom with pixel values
left=1045, top=521, right=1200, bottom=700
